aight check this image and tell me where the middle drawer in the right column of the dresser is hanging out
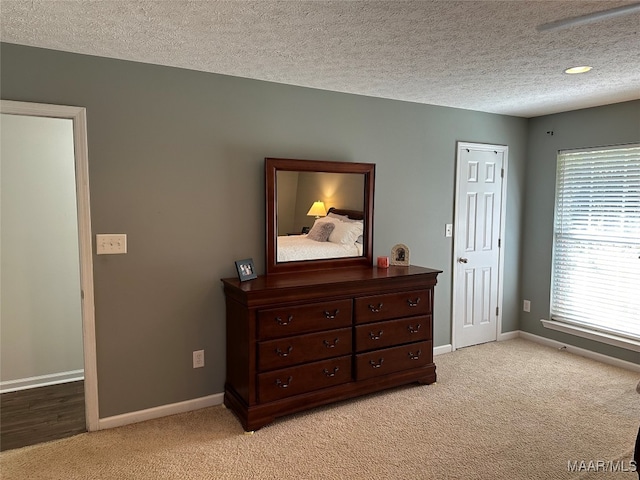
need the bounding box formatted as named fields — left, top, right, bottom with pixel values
left=355, top=315, right=431, bottom=352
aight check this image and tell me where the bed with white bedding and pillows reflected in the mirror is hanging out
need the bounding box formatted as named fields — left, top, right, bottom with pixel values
left=277, top=207, right=364, bottom=262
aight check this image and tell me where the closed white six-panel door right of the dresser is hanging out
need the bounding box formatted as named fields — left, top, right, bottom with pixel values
left=452, top=142, right=508, bottom=348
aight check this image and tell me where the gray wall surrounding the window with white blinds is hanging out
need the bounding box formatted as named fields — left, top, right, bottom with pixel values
left=520, top=101, right=640, bottom=363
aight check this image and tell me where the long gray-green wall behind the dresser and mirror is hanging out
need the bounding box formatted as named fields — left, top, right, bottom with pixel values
left=0, top=44, right=527, bottom=418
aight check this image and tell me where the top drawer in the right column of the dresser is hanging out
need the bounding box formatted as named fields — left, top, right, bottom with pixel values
left=355, top=290, right=433, bottom=323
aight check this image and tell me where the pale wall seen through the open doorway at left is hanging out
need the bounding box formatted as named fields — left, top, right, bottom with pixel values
left=0, top=114, right=84, bottom=388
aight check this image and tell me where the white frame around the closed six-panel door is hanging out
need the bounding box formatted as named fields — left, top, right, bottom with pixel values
left=451, top=141, right=509, bottom=351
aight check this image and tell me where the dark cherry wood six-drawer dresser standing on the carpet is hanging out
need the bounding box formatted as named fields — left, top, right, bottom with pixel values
left=222, top=266, right=441, bottom=431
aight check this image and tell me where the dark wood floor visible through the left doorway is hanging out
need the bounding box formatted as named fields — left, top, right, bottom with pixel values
left=0, top=381, right=87, bottom=450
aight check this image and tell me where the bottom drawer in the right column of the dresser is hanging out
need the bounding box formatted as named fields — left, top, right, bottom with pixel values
left=356, top=341, right=433, bottom=380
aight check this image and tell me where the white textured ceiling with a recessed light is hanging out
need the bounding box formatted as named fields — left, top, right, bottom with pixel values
left=0, top=0, right=640, bottom=117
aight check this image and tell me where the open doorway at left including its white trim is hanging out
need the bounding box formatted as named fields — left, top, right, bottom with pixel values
left=0, top=100, right=98, bottom=449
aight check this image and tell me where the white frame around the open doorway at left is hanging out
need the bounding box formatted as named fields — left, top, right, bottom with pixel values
left=0, top=100, right=99, bottom=431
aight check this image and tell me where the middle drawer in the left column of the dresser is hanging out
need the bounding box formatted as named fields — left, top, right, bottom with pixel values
left=258, top=328, right=352, bottom=372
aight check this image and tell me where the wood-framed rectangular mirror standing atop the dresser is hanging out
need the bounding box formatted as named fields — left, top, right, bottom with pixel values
left=265, top=158, right=375, bottom=275
